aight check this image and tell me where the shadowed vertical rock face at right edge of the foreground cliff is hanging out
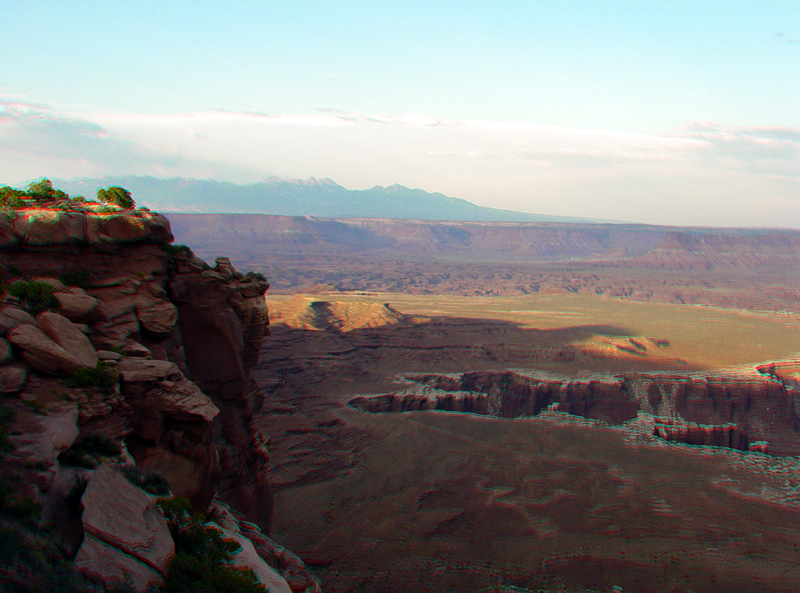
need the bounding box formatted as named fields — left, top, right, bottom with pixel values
left=168, top=261, right=272, bottom=531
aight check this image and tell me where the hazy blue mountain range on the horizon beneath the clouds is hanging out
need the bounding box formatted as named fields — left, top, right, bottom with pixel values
left=47, top=176, right=597, bottom=222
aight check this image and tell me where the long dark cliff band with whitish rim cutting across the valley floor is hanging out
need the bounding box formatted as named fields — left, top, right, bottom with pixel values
left=349, top=363, right=800, bottom=455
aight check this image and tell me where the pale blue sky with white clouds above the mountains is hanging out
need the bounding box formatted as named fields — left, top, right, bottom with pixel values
left=0, top=0, right=800, bottom=228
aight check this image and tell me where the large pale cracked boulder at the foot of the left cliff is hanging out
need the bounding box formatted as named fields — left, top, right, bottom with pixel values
left=75, top=465, right=175, bottom=591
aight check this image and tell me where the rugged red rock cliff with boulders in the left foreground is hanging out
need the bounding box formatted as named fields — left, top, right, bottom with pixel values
left=0, top=200, right=319, bottom=591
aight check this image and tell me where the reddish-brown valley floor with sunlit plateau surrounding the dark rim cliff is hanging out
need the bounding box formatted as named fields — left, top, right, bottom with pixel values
left=254, top=293, right=800, bottom=593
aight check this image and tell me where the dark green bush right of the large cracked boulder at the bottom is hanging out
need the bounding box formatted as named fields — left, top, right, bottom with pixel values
left=158, top=498, right=267, bottom=593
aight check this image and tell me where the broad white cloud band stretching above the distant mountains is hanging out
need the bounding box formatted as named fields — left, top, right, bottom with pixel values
left=0, top=101, right=800, bottom=227
